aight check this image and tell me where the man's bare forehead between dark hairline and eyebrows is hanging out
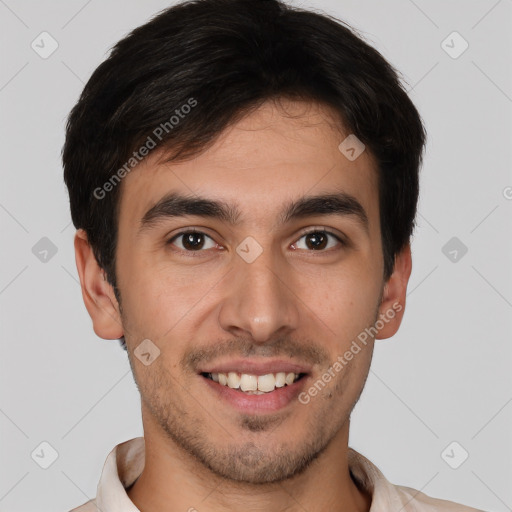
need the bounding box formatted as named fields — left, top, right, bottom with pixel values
left=120, top=97, right=378, bottom=228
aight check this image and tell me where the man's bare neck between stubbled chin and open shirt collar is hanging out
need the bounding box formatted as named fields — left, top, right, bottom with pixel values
left=127, top=421, right=371, bottom=512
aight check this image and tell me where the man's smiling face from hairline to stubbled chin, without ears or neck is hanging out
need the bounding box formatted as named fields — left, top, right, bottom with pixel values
left=80, top=102, right=408, bottom=483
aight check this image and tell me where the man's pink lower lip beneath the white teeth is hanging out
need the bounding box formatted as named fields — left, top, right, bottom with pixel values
left=200, top=375, right=308, bottom=413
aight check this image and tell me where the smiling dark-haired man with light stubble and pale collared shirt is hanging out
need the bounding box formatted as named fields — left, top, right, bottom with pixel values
left=63, top=0, right=484, bottom=512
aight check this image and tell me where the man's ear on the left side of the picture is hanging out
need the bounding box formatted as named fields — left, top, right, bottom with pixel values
left=75, top=229, right=123, bottom=340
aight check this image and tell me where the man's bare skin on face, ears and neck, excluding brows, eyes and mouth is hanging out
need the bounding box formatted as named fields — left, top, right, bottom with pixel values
left=75, top=100, right=411, bottom=512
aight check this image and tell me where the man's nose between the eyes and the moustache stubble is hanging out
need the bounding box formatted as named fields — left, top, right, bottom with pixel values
left=219, top=245, right=300, bottom=343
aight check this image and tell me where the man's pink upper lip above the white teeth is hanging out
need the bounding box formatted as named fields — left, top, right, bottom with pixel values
left=199, top=359, right=311, bottom=375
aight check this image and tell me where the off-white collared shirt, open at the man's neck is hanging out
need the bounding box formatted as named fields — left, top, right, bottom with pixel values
left=71, top=437, right=483, bottom=512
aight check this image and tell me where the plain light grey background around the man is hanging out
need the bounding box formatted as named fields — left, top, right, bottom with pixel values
left=0, top=0, right=512, bottom=512
